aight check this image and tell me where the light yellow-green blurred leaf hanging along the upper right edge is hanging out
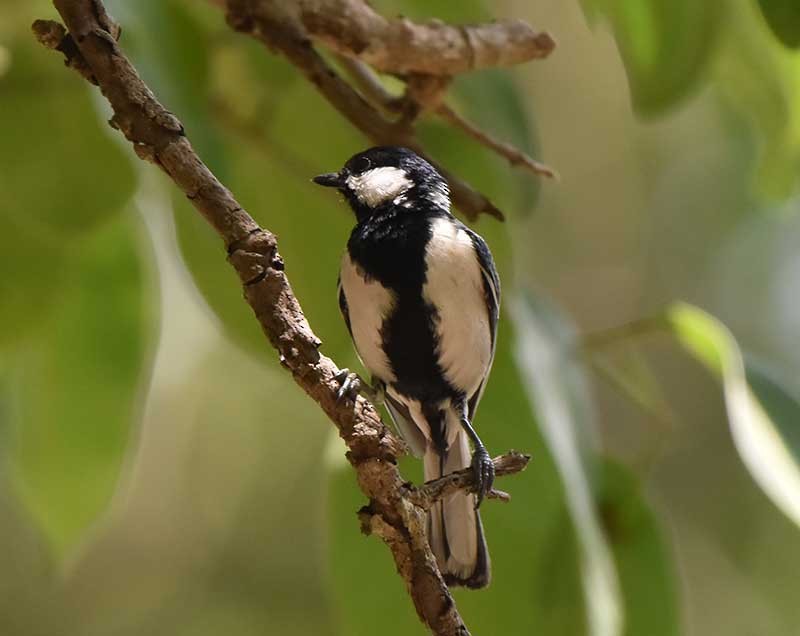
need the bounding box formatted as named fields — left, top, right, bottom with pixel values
left=715, top=2, right=800, bottom=199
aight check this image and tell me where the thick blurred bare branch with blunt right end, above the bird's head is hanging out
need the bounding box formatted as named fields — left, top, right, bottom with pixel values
left=297, top=0, right=555, bottom=76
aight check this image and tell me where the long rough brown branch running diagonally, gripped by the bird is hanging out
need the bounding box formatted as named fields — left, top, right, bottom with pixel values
left=33, top=0, right=524, bottom=636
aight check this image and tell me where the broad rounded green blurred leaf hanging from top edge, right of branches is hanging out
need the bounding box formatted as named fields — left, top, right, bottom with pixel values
left=583, top=0, right=728, bottom=116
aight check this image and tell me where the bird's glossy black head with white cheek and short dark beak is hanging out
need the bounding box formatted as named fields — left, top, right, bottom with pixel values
left=314, top=146, right=450, bottom=220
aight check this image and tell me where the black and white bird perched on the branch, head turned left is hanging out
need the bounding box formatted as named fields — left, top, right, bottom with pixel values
left=314, top=146, right=500, bottom=588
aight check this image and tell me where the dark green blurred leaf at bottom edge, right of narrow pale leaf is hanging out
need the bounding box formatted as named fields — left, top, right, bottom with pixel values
left=598, top=460, right=681, bottom=636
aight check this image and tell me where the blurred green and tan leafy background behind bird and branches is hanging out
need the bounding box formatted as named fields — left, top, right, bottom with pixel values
left=0, top=0, right=800, bottom=636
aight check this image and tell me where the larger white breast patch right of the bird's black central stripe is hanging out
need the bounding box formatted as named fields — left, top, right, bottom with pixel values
left=423, top=219, right=492, bottom=395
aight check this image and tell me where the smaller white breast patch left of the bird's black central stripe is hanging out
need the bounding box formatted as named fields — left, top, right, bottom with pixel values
left=341, top=252, right=396, bottom=383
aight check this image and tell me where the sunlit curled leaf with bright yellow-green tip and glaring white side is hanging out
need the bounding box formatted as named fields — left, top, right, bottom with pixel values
left=667, top=304, right=800, bottom=525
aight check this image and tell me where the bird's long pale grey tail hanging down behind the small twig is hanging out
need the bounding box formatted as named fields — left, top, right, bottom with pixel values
left=424, top=431, right=491, bottom=588
